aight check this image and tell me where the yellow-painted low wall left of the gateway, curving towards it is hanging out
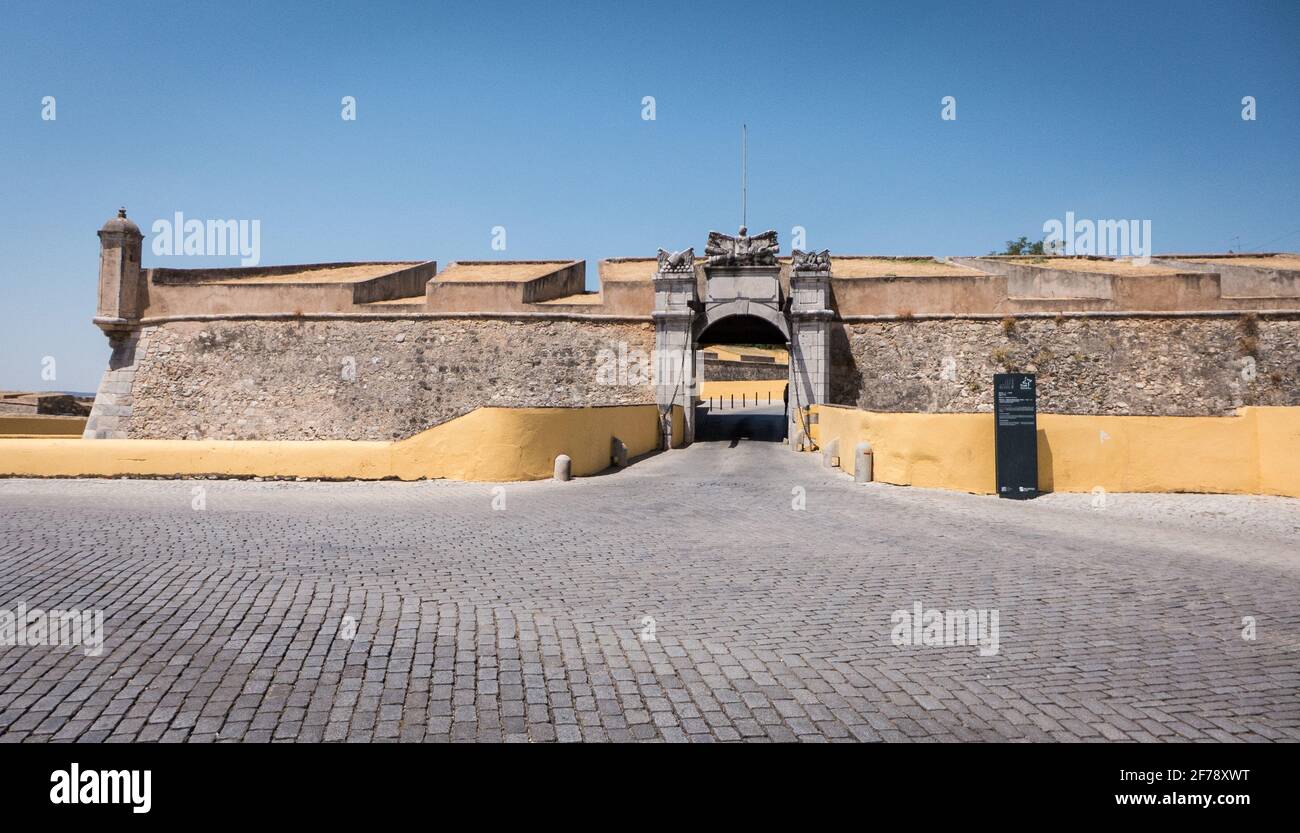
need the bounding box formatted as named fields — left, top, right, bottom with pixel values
left=0, top=405, right=684, bottom=481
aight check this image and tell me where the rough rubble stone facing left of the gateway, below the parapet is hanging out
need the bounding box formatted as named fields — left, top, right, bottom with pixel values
left=130, top=318, right=654, bottom=439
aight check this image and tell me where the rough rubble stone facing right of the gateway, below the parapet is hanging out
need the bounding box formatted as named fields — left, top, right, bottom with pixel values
left=831, top=316, right=1300, bottom=416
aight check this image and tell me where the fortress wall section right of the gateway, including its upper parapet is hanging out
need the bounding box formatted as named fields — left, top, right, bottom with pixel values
left=828, top=255, right=1300, bottom=416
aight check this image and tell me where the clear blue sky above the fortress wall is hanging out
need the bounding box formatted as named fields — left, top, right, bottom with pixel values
left=0, top=0, right=1300, bottom=391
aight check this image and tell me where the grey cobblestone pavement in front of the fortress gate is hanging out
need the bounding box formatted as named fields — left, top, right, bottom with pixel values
left=0, top=441, right=1300, bottom=742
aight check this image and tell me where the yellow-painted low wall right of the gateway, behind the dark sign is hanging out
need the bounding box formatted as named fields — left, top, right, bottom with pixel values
left=813, top=405, right=1300, bottom=498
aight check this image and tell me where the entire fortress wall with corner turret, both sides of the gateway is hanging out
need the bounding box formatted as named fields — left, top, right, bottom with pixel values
left=86, top=212, right=1300, bottom=441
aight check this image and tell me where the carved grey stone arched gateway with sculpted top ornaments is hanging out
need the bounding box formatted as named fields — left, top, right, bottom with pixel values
left=654, top=227, right=833, bottom=448
